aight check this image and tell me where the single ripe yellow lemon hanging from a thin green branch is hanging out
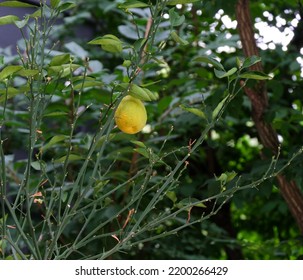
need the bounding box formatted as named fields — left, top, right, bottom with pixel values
left=115, top=95, right=147, bottom=134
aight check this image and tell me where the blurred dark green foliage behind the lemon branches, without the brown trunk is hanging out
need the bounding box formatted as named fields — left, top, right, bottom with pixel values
left=1, top=0, right=303, bottom=259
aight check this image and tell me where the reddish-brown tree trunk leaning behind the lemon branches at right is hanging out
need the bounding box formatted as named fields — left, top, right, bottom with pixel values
left=236, top=0, right=303, bottom=234
